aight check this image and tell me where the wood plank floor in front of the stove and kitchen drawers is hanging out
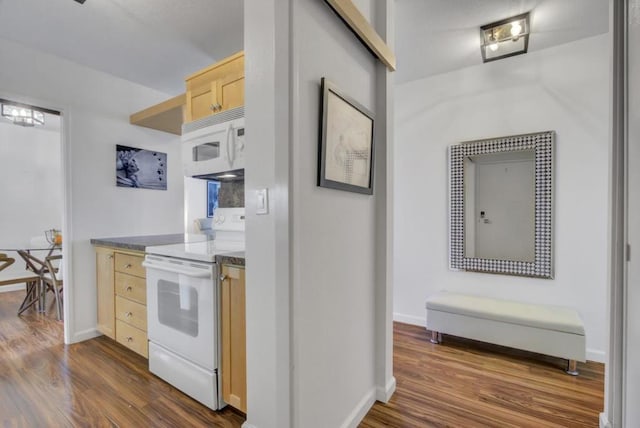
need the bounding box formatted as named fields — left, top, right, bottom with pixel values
left=0, top=291, right=245, bottom=428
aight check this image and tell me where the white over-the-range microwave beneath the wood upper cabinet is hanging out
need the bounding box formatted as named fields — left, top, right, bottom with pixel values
left=182, top=107, right=244, bottom=178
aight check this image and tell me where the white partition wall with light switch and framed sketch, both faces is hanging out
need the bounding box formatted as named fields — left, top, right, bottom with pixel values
left=245, top=0, right=392, bottom=428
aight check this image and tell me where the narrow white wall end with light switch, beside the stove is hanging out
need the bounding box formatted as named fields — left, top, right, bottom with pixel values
left=243, top=0, right=292, bottom=428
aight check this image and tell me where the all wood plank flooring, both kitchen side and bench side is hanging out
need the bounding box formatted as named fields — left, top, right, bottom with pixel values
left=0, top=292, right=604, bottom=428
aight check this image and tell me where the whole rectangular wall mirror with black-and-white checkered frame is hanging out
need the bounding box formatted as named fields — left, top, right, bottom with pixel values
left=449, top=131, right=555, bottom=278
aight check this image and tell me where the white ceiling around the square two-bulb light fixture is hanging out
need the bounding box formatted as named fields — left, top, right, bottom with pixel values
left=395, top=0, right=609, bottom=83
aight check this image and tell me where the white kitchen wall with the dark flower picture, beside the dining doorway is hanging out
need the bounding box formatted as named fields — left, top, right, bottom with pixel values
left=0, top=40, right=184, bottom=342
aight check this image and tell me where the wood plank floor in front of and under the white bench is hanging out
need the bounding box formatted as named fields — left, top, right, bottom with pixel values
left=360, top=323, right=604, bottom=428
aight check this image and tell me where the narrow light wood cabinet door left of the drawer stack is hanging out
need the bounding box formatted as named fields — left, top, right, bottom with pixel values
left=96, top=247, right=116, bottom=339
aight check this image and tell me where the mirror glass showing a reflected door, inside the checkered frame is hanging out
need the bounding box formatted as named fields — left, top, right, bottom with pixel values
left=463, top=149, right=535, bottom=262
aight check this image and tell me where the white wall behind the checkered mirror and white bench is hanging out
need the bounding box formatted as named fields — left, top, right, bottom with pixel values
left=394, top=35, right=609, bottom=361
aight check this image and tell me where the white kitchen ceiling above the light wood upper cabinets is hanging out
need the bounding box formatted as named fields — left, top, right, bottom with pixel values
left=0, top=0, right=243, bottom=95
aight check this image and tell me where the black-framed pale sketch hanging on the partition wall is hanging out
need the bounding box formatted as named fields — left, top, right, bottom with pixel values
left=318, top=77, right=374, bottom=195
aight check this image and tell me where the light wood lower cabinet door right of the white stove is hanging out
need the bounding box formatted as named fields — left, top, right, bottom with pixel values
left=221, top=265, right=247, bottom=412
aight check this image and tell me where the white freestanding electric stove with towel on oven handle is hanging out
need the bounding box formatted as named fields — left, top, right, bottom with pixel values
left=143, top=208, right=244, bottom=410
